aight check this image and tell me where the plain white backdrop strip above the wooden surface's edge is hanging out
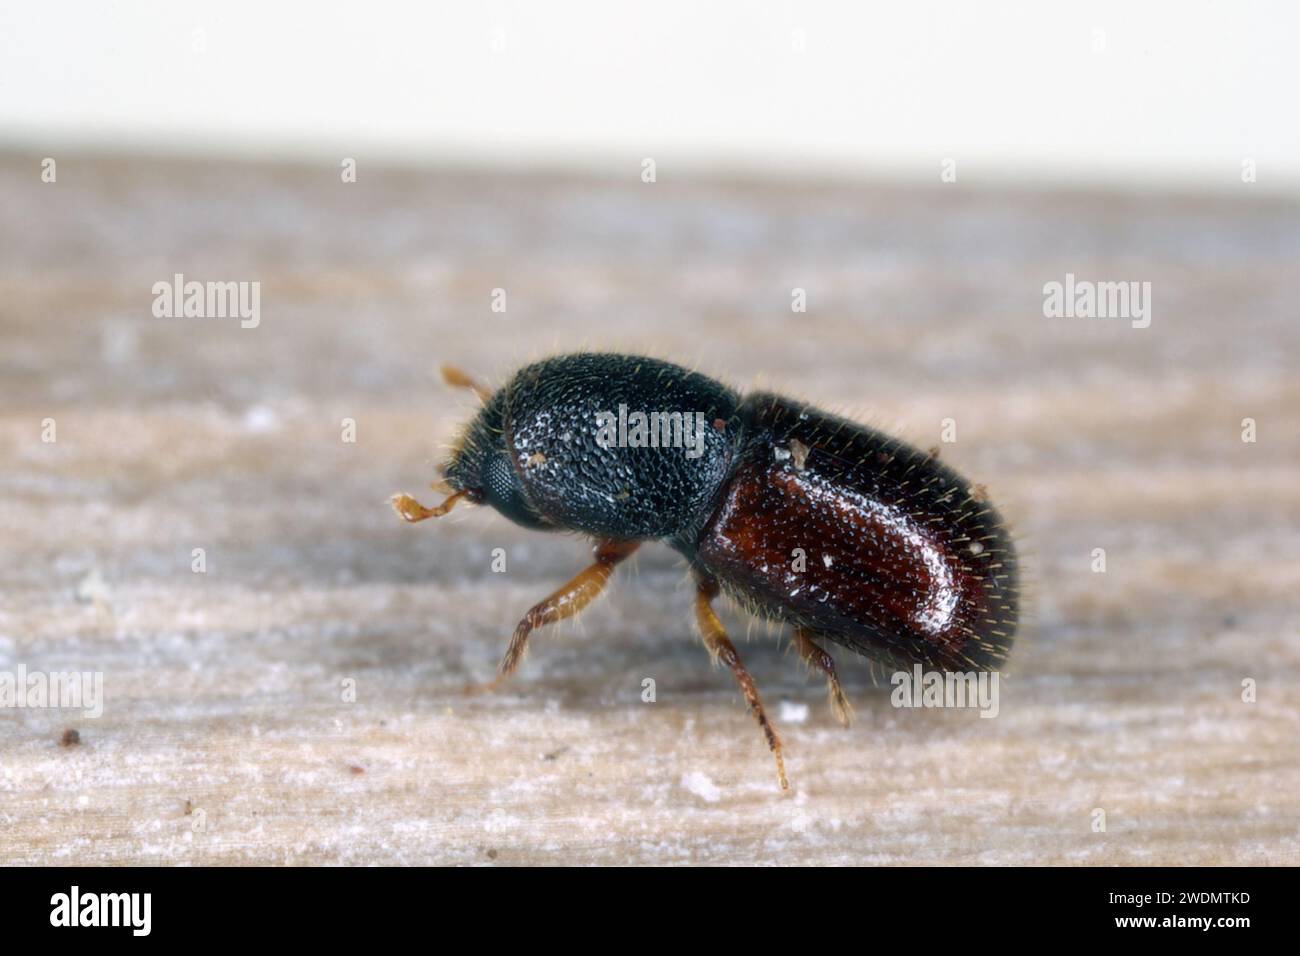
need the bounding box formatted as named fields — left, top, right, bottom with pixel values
left=0, top=0, right=1300, bottom=189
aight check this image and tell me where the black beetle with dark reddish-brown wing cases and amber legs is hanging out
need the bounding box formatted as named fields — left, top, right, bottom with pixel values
left=393, top=352, right=1019, bottom=790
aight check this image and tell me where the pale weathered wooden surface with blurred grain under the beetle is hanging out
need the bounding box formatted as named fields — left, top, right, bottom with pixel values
left=0, top=155, right=1300, bottom=864
